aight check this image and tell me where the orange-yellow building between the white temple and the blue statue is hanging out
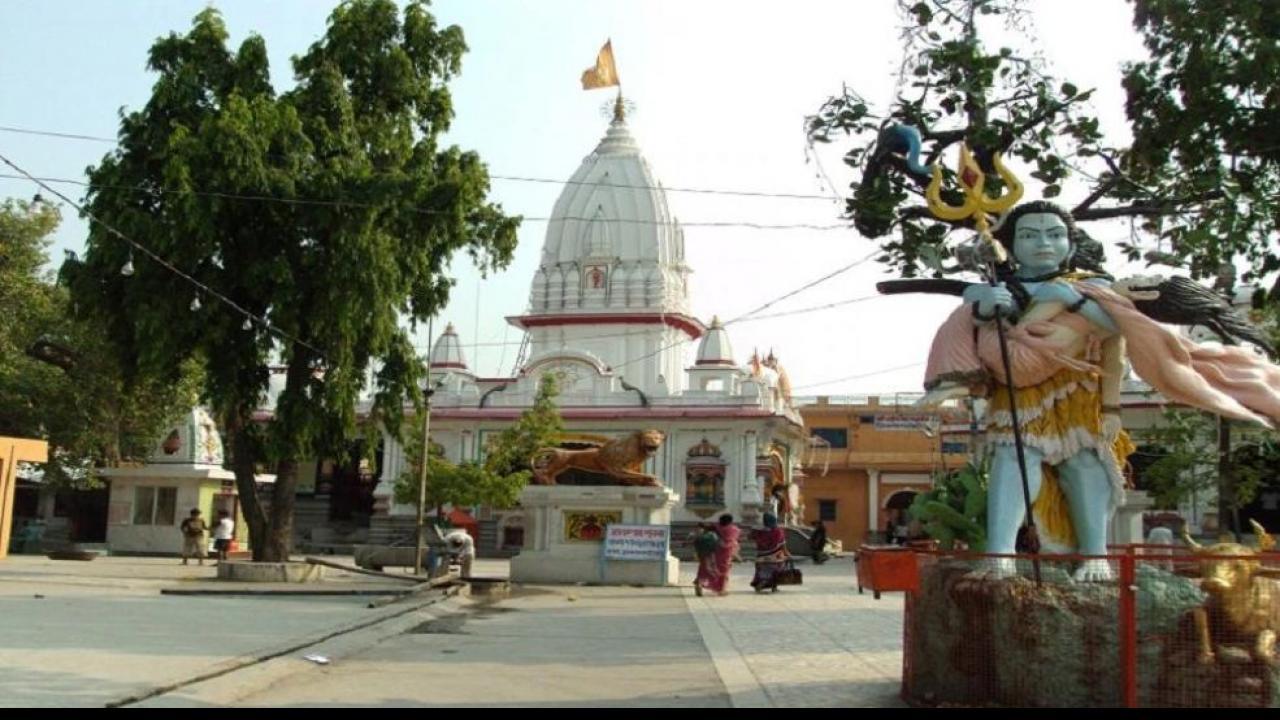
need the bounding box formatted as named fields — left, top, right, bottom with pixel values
left=800, top=395, right=975, bottom=550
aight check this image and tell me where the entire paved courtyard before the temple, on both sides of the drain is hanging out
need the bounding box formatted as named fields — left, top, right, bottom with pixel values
left=0, top=556, right=902, bottom=707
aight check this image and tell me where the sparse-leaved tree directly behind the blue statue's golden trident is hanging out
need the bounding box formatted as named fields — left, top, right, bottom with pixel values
left=808, top=0, right=1101, bottom=277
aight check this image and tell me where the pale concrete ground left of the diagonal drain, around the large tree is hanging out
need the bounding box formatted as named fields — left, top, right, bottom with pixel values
left=0, top=555, right=455, bottom=707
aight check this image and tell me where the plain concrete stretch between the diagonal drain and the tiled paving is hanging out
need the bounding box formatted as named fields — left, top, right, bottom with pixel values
left=220, top=579, right=730, bottom=707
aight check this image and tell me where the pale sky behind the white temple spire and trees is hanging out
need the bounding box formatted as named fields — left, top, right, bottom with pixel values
left=0, top=0, right=1143, bottom=396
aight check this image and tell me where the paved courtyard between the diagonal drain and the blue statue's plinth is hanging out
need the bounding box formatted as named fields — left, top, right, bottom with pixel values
left=212, top=560, right=902, bottom=707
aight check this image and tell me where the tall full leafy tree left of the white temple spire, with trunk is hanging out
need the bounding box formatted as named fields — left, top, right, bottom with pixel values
left=73, top=0, right=518, bottom=560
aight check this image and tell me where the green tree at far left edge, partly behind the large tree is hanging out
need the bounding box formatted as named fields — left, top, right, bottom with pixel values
left=0, top=200, right=200, bottom=487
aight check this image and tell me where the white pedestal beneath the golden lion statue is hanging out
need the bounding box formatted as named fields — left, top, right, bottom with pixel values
left=511, top=484, right=680, bottom=585
